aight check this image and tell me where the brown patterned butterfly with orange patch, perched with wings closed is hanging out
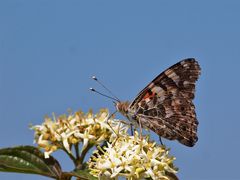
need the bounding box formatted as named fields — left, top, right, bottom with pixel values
left=115, top=58, right=201, bottom=147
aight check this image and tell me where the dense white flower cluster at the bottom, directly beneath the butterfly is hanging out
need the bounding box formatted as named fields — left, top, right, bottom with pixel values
left=88, top=132, right=177, bottom=180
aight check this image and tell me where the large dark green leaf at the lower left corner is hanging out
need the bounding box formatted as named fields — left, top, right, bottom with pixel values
left=0, top=146, right=62, bottom=179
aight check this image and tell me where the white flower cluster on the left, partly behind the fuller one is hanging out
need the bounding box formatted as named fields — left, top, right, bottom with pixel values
left=31, top=109, right=128, bottom=158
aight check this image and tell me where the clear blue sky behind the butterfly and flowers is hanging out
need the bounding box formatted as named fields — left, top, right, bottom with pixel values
left=0, top=0, right=240, bottom=180
